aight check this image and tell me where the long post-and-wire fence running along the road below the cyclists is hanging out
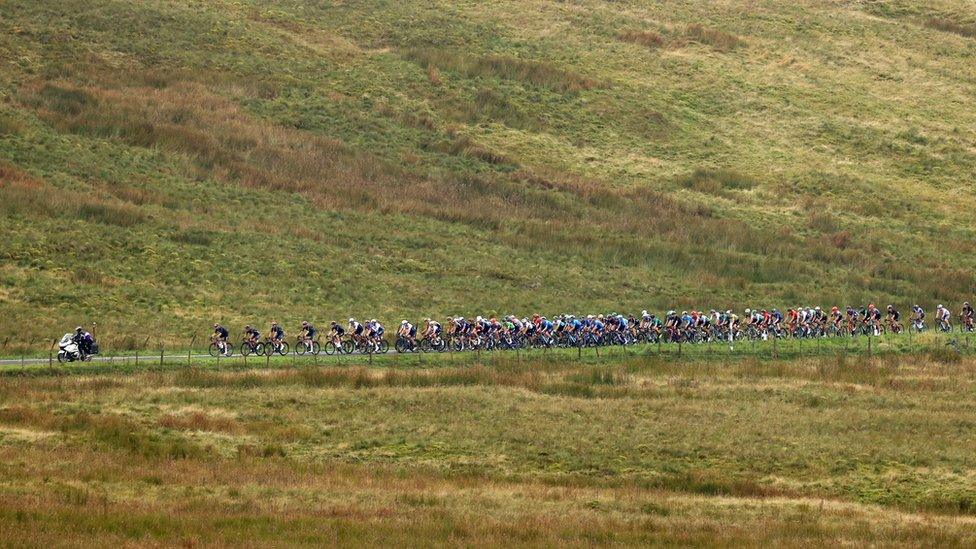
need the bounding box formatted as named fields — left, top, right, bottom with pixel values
left=0, top=332, right=976, bottom=371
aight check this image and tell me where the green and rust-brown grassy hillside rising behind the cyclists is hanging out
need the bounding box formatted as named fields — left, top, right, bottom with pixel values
left=0, top=0, right=976, bottom=341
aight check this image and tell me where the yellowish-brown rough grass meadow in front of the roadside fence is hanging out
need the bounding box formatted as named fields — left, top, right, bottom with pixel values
left=0, top=355, right=976, bottom=546
